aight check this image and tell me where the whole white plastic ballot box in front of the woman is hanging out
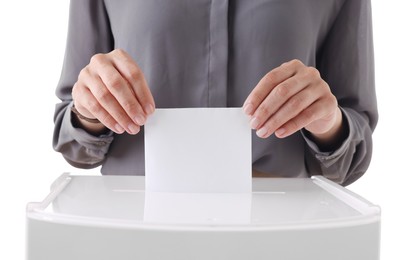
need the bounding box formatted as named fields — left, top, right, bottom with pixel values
left=26, top=174, right=380, bottom=260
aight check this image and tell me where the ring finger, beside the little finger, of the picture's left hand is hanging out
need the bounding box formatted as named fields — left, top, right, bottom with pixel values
left=84, top=69, right=140, bottom=134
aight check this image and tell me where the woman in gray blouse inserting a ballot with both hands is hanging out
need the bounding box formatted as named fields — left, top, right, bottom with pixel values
left=53, top=0, right=378, bottom=185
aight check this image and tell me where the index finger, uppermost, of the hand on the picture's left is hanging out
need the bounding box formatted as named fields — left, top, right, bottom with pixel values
left=112, top=49, right=155, bottom=115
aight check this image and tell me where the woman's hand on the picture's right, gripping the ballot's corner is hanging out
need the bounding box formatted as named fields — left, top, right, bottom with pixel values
left=243, top=60, right=342, bottom=142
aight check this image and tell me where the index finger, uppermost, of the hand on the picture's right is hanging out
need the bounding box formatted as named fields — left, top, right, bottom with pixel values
left=243, top=60, right=303, bottom=116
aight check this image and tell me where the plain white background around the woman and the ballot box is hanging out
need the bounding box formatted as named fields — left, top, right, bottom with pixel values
left=0, top=0, right=407, bottom=260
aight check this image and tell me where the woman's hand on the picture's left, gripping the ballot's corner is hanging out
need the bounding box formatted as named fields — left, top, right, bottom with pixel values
left=72, top=49, right=155, bottom=134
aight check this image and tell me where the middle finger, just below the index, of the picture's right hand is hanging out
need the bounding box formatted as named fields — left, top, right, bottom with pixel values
left=250, top=75, right=308, bottom=129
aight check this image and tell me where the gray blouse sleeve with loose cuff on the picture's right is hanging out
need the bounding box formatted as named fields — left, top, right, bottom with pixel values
left=303, top=0, right=378, bottom=185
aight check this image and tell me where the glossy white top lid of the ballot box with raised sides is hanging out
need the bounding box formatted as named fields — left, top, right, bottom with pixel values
left=27, top=174, right=380, bottom=230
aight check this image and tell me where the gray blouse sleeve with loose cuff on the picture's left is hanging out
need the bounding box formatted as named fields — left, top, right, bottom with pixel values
left=53, top=0, right=113, bottom=168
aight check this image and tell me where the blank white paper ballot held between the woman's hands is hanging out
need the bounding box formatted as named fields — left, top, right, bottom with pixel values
left=144, top=108, right=252, bottom=193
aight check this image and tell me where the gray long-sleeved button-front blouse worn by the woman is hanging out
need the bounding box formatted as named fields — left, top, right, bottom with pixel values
left=53, top=0, right=378, bottom=185
